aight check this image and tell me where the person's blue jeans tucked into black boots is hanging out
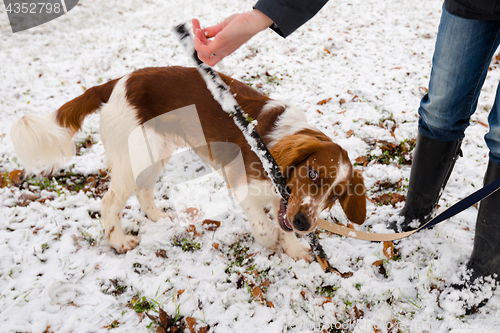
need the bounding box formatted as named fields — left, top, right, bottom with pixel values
left=418, top=6, right=500, bottom=164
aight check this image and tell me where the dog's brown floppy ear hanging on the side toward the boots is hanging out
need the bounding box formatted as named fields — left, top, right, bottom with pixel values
left=339, top=170, right=366, bottom=224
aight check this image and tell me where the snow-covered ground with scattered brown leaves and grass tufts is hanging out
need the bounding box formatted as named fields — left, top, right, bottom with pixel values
left=0, top=0, right=500, bottom=333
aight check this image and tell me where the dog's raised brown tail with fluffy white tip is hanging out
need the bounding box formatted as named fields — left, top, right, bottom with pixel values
left=10, top=79, right=118, bottom=173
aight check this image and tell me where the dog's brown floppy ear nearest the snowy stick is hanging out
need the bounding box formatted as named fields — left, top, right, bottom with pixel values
left=271, top=134, right=322, bottom=177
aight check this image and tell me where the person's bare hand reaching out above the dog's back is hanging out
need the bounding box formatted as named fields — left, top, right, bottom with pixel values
left=193, top=9, right=273, bottom=66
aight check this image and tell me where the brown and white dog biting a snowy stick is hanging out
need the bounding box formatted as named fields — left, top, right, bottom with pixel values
left=11, top=67, right=366, bottom=260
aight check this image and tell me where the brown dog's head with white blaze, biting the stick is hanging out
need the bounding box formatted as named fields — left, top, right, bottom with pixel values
left=271, top=132, right=366, bottom=234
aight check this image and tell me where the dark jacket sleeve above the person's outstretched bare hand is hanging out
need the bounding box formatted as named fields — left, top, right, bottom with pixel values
left=253, top=0, right=328, bottom=37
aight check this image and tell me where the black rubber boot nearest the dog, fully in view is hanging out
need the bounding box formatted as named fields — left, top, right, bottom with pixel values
left=389, top=131, right=462, bottom=232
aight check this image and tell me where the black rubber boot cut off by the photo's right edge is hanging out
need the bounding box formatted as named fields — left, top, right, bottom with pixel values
left=467, top=160, right=500, bottom=282
